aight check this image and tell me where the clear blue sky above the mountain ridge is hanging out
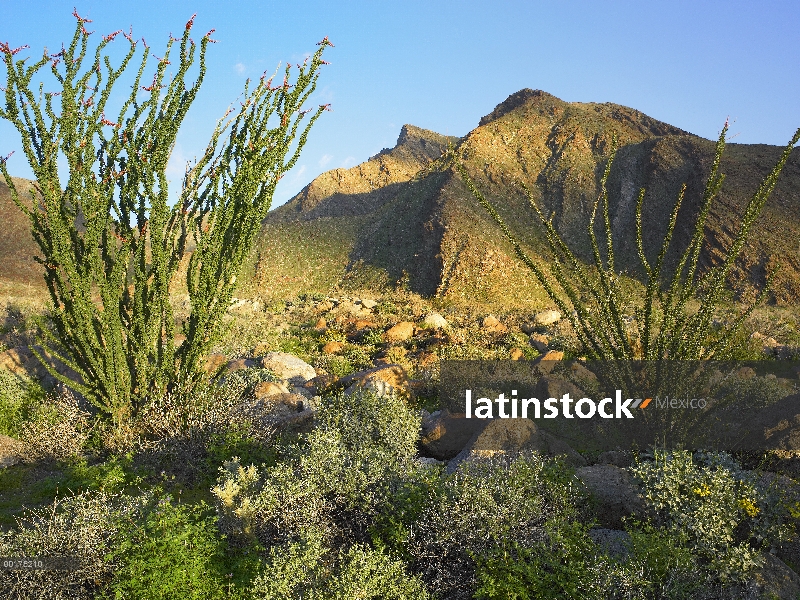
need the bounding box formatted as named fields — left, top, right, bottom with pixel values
left=0, top=0, right=800, bottom=206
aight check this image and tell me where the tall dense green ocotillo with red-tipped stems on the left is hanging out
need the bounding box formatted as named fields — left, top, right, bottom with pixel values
left=0, top=13, right=331, bottom=422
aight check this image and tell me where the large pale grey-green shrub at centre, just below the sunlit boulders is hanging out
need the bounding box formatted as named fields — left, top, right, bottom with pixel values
left=212, top=393, right=419, bottom=546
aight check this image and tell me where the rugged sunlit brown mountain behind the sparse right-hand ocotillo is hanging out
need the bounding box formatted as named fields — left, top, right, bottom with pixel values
left=254, top=89, right=800, bottom=303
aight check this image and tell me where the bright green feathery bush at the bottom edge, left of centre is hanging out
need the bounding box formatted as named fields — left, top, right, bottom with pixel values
left=102, top=495, right=257, bottom=600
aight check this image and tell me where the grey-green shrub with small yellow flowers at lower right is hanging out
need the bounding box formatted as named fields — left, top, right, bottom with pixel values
left=631, top=449, right=791, bottom=581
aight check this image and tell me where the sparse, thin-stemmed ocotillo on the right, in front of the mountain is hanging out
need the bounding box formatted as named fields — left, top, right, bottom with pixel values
left=451, top=123, right=800, bottom=360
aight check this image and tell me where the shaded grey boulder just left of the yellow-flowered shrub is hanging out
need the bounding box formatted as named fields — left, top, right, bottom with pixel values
left=575, top=465, right=646, bottom=529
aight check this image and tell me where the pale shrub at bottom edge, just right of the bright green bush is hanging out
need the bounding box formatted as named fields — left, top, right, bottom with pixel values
left=248, top=537, right=428, bottom=600
